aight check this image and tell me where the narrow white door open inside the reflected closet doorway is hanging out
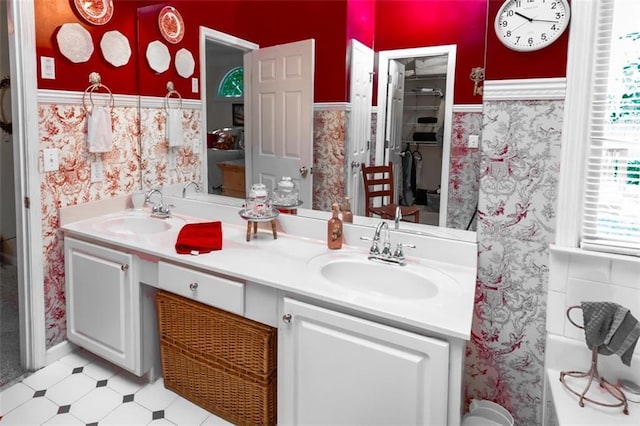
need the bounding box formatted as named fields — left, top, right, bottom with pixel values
left=384, top=59, right=404, bottom=203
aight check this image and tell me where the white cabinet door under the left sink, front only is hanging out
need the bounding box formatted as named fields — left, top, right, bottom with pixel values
left=65, top=238, right=139, bottom=371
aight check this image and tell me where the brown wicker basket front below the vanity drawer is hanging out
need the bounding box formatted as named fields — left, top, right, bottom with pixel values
left=156, top=291, right=277, bottom=425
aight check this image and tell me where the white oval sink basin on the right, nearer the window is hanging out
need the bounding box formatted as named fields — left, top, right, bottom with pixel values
left=308, top=253, right=456, bottom=300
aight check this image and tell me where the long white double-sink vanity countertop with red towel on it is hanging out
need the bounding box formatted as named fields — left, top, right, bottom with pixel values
left=61, top=198, right=476, bottom=340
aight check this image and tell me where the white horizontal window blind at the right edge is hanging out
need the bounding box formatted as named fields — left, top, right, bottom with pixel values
left=581, top=0, right=640, bottom=256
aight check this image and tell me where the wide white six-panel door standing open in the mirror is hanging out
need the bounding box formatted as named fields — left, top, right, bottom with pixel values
left=246, top=39, right=315, bottom=208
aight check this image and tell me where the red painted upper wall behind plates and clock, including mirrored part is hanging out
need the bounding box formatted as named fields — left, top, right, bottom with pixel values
left=35, top=0, right=568, bottom=104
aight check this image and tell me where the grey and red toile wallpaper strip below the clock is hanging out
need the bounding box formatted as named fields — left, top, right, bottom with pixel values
left=464, top=101, right=564, bottom=425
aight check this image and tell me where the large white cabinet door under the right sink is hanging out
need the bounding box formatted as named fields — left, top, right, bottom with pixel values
left=278, top=298, right=449, bottom=425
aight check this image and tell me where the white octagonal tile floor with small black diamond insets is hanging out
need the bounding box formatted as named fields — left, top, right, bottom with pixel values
left=0, top=350, right=231, bottom=426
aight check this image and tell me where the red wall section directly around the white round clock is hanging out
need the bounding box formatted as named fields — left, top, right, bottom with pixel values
left=485, top=0, right=571, bottom=80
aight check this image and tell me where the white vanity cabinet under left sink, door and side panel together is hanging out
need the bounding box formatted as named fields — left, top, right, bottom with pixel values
left=64, top=237, right=155, bottom=376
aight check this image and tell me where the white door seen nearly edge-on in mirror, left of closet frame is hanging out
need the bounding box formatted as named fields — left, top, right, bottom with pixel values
left=345, top=39, right=374, bottom=215
